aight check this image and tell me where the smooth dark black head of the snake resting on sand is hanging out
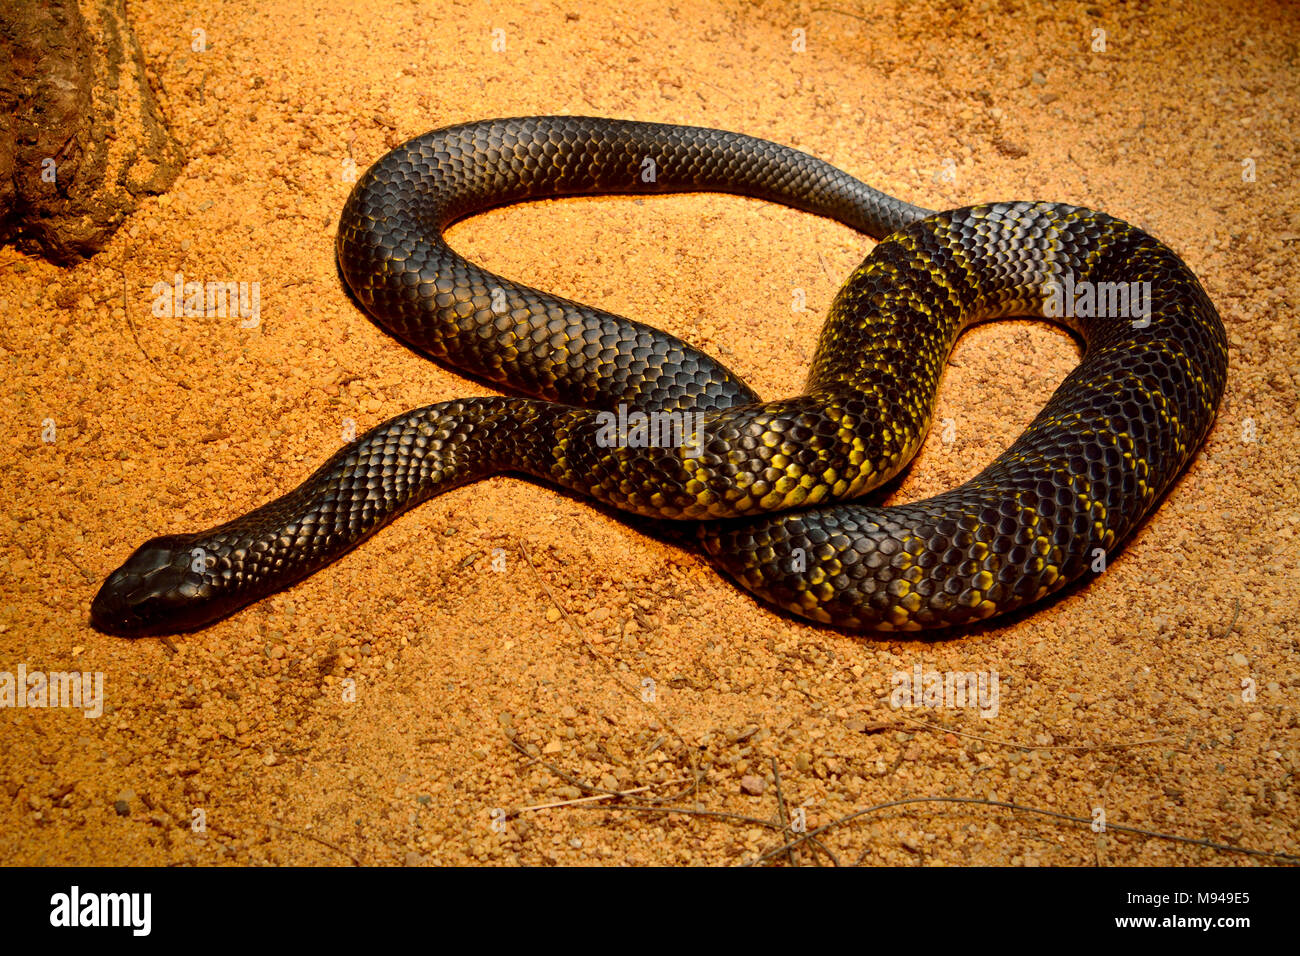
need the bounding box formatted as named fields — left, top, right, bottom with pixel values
left=90, top=535, right=213, bottom=637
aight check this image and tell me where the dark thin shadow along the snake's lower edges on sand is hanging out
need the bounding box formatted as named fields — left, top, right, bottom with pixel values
left=334, top=256, right=1201, bottom=644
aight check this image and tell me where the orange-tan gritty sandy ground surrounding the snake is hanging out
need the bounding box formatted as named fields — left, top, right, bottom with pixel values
left=0, top=0, right=1300, bottom=865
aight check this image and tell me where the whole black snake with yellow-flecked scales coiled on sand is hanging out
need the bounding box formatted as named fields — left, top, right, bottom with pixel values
left=91, top=116, right=1227, bottom=636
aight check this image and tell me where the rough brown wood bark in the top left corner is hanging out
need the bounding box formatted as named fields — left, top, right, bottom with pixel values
left=0, top=0, right=185, bottom=264
